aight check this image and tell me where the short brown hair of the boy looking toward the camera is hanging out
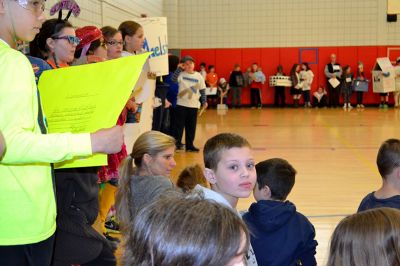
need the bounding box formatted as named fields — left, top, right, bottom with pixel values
left=203, top=133, right=251, bottom=170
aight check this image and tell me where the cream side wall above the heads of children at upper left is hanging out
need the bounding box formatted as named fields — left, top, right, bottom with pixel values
left=46, top=0, right=163, bottom=28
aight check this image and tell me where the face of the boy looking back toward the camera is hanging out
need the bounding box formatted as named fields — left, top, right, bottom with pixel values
left=207, top=147, right=257, bottom=205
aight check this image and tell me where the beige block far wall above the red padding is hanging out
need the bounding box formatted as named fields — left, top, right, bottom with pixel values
left=164, top=0, right=400, bottom=49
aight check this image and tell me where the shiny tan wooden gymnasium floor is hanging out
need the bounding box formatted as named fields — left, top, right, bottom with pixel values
left=173, top=108, right=400, bottom=265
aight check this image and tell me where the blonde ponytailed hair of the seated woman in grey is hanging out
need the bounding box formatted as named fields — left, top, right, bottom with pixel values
left=115, top=131, right=175, bottom=233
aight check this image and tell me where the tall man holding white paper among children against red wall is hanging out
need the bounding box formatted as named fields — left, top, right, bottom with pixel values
left=324, top=54, right=342, bottom=107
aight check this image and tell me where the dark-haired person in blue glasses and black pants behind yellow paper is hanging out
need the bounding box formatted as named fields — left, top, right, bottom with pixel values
left=30, top=19, right=116, bottom=266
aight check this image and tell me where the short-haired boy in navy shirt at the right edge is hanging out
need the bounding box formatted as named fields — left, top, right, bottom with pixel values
left=357, top=139, right=400, bottom=212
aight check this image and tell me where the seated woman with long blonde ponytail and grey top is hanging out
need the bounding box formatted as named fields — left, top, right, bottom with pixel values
left=116, top=131, right=176, bottom=233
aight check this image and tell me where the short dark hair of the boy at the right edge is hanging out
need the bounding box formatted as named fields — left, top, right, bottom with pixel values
left=376, top=139, right=400, bottom=179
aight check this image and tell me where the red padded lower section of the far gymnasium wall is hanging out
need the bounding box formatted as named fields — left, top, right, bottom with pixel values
left=181, top=46, right=400, bottom=104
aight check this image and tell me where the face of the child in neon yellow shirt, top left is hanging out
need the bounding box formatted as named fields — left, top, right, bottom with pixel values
left=0, top=0, right=46, bottom=41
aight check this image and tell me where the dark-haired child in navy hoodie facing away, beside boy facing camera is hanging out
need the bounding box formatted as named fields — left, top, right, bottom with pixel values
left=243, top=158, right=318, bottom=266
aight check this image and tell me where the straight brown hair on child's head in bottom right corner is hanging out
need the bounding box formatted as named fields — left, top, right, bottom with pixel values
left=327, top=208, right=400, bottom=266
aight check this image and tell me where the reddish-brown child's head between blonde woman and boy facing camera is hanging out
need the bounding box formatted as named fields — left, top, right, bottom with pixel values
left=176, top=164, right=208, bottom=193
